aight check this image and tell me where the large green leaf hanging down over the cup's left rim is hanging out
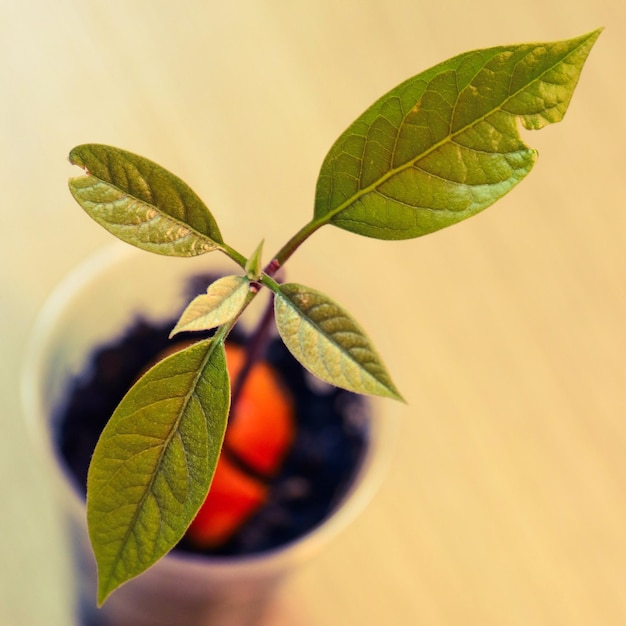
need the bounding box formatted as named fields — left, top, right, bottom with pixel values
left=87, top=340, right=230, bottom=603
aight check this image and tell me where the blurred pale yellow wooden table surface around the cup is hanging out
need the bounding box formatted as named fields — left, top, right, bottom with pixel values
left=0, top=0, right=626, bottom=626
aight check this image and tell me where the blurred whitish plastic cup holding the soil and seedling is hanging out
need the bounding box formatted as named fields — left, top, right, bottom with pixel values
left=22, top=243, right=396, bottom=626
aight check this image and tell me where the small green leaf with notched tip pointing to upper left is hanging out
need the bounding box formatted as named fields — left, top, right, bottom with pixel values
left=69, top=144, right=223, bottom=257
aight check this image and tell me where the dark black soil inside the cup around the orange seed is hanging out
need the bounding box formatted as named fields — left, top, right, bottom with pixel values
left=57, top=276, right=369, bottom=555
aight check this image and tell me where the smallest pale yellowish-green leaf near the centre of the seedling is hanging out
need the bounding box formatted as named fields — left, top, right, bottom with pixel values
left=170, top=276, right=250, bottom=337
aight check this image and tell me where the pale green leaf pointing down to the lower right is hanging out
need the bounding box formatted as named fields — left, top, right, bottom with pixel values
left=274, top=283, right=402, bottom=399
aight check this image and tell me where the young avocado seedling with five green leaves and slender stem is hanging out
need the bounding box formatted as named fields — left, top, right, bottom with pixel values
left=70, top=30, right=600, bottom=603
